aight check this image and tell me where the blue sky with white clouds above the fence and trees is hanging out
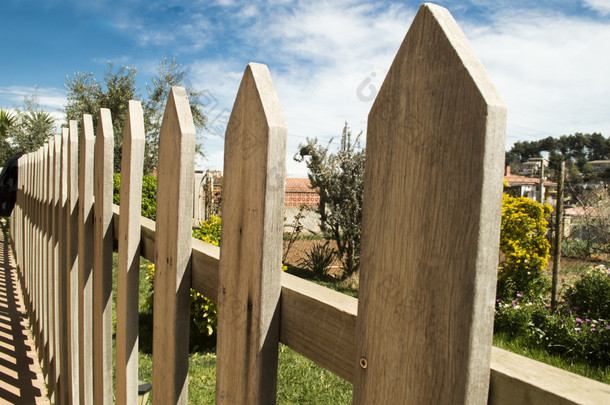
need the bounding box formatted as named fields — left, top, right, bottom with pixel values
left=0, top=0, right=610, bottom=176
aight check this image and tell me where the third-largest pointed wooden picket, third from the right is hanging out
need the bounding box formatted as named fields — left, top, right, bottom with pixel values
left=153, top=87, right=195, bottom=405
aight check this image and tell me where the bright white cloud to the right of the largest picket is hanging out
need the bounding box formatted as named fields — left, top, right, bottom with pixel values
left=466, top=9, right=610, bottom=147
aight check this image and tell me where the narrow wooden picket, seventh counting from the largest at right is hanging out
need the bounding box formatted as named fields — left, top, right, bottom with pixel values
left=66, top=120, right=80, bottom=403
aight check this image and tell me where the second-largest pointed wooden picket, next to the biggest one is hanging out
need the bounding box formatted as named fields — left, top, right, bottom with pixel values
left=216, top=63, right=287, bottom=404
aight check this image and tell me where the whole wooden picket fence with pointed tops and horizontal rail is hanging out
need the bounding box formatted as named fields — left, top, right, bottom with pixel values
left=5, top=5, right=610, bottom=405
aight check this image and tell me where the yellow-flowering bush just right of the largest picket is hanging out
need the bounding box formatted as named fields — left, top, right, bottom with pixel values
left=496, top=194, right=552, bottom=299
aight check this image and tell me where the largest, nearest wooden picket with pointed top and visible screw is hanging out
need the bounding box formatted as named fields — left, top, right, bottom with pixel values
left=353, top=4, right=506, bottom=404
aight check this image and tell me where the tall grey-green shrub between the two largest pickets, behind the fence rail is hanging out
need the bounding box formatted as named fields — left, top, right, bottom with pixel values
left=294, top=123, right=365, bottom=277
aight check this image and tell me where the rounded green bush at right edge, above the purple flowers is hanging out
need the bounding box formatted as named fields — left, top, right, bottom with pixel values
left=564, top=265, right=610, bottom=320
